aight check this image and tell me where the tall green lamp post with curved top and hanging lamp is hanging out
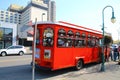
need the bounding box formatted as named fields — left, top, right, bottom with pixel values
left=101, top=6, right=116, bottom=71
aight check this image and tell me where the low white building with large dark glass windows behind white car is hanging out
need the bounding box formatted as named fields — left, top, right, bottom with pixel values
left=0, top=22, right=17, bottom=49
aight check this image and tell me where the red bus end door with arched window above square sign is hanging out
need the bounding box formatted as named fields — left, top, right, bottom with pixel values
left=42, top=27, right=54, bottom=66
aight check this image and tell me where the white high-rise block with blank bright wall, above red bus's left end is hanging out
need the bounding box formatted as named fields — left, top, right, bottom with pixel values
left=21, top=0, right=48, bottom=25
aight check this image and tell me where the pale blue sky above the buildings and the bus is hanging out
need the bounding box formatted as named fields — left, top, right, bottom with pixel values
left=0, top=0, right=120, bottom=40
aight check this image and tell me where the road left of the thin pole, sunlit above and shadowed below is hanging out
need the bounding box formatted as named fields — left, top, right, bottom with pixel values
left=0, top=55, right=31, bottom=80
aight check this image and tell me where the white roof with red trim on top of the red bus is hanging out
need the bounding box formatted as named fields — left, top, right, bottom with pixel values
left=33, top=21, right=102, bottom=34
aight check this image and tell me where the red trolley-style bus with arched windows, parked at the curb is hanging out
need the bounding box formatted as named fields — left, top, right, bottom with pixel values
left=34, top=21, right=102, bottom=70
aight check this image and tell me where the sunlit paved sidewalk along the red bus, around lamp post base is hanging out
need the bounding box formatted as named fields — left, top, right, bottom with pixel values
left=45, top=61, right=120, bottom=80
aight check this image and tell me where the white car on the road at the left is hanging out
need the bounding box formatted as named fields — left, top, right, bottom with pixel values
left=0, top=45, right=26, bottom=56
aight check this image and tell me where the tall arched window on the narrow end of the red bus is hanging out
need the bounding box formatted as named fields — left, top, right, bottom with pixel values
left=43, top=28, right=53, bottom=47
